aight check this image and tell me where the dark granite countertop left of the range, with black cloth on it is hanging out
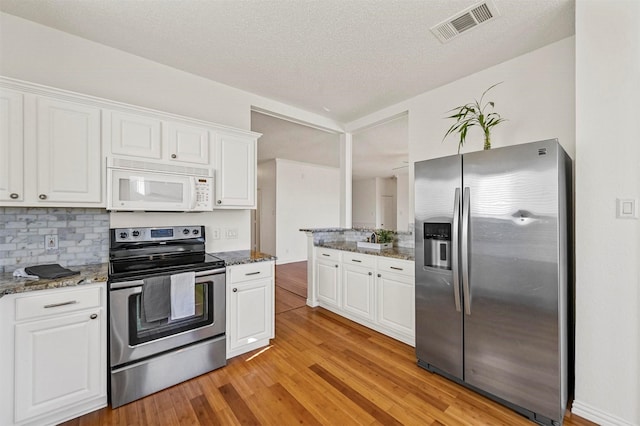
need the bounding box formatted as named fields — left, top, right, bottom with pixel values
left=0, top=263, right=108, bottom=297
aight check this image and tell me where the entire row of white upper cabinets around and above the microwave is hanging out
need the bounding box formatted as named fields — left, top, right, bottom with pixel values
left=0, top=76, right=261, bottom=209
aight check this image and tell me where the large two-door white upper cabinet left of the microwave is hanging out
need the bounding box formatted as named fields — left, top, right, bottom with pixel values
left=0, top=89, right=104, bottom=207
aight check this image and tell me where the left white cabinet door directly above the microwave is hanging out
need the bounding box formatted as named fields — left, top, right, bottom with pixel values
left=107, top=111, right=162, bottom=160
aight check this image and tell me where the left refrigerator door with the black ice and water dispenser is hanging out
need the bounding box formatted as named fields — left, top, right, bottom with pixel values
left=414, top=155, right=463, bottom=380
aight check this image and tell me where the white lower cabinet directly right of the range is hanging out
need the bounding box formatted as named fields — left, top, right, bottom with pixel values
left=227, top=261, right=275, bottom=358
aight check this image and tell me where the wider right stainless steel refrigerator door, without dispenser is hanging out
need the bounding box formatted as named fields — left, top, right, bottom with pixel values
left=461, top=140, right=566, bottom=421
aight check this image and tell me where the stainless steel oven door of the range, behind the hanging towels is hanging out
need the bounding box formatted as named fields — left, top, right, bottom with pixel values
left=109, top=269, right=226, bottom=367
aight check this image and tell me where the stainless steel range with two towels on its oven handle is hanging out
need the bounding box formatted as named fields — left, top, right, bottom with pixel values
left=109, top=226, right=227, bottom=408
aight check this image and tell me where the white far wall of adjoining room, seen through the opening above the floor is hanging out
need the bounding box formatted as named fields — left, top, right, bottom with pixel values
left=276, top=159, right=340, bottom=264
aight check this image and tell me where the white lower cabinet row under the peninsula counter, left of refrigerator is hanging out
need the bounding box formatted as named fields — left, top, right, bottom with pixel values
left=312, top=247, right=415, bottom=346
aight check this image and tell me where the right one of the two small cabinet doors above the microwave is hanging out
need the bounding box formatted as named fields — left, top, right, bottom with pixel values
left=165, top=122, right=209, bottom=164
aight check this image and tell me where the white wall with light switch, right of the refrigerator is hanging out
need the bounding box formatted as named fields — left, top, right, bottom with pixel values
left=574, top=0, right=640, bottom=425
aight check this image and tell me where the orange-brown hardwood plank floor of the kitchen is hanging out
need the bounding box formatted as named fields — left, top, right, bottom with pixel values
left=65, top=265, right=593, bottom=426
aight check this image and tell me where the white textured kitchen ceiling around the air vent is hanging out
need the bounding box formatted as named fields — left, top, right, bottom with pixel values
left=0, top=0, right=575, bottom=123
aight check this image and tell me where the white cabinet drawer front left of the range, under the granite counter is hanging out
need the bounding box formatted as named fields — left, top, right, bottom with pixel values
left=16, top=287, right=101, bottom=321
